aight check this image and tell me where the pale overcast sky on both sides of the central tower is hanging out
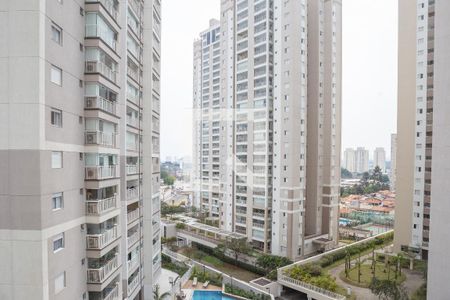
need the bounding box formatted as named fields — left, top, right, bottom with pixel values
left=161, top=0, right=397, bottom=160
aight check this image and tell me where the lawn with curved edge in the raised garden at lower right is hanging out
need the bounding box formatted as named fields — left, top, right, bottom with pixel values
left=339, top=263, right=406, bottom=287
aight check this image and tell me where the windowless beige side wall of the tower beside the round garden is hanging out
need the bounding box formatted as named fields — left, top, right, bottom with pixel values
left=394, top=0, right=417, bottom=251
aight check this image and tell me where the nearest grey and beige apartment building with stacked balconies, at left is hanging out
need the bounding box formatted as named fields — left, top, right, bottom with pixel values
left=0, top=0, right=161, bottom=300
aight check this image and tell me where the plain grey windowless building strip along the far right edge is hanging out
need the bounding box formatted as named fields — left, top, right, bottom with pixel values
left=424, top=1, right=450, bottom=299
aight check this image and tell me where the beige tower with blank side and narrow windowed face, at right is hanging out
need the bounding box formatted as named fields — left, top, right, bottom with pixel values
left=394, top=0, right=435, bottom=258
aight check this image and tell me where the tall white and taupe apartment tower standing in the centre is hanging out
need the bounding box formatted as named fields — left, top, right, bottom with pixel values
left=194, top=0, right=341, bottom=259
